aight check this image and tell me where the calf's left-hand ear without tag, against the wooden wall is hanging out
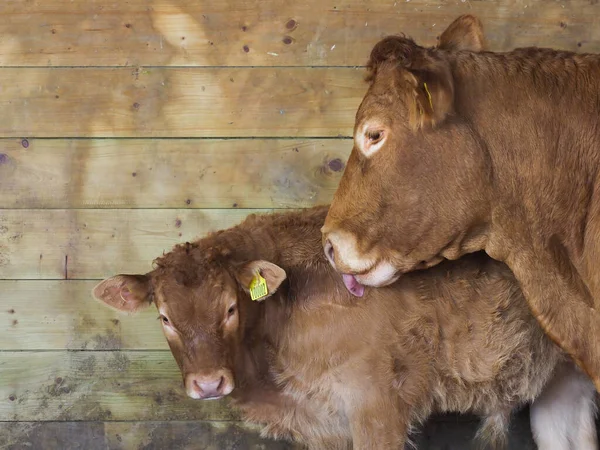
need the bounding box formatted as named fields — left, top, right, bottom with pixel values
left=92, top=275, right=152, bottom=314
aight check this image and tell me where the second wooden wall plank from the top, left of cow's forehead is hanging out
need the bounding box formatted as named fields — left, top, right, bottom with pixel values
left=0, top=68, right=366, bottom=138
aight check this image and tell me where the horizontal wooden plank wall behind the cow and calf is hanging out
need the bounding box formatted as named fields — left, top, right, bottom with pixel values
left=0, top=0, right=600, bottom=450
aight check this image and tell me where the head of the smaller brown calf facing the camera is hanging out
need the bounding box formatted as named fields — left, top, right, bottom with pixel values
left=92, top=250, right=286, bottom=399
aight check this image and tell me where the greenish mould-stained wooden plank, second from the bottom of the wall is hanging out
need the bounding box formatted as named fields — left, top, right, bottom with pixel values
left=0, top=351, right=239, bottom=421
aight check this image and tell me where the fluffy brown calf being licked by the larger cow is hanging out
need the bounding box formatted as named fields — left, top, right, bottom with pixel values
left=94, top=207, right=598, bottom=450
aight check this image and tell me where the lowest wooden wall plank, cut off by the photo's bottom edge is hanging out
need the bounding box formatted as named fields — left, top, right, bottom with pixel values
left=0, top=421, right=302, bottom=450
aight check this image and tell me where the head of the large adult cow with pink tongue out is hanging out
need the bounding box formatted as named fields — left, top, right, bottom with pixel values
left=322, top=16, right=486, bottom=296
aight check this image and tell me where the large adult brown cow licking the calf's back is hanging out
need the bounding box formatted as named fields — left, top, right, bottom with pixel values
left=322, top=16, right=600, bottom=390
